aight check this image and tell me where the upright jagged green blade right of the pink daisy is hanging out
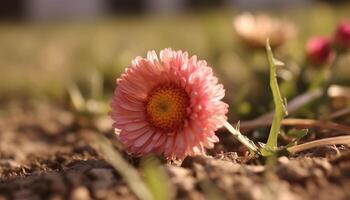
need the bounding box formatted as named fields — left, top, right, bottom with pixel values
left=262, top=40, right=287, bottom=156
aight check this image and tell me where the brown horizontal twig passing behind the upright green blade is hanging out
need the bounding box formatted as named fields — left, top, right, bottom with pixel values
left=240, top=118, right=350, bottom=134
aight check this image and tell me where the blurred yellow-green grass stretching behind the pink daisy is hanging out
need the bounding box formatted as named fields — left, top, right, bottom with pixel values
left=0, top=4, right=350, bottom=120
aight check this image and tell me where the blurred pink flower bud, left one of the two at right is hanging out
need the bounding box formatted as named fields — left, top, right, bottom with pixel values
left=306, top=36, right=333, bottom=65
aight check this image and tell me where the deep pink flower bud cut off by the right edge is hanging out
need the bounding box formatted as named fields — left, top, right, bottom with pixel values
left=334, top=21, right=350, bottom=50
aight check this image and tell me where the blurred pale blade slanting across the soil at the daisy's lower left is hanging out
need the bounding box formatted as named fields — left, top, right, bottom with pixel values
left=94, top=134, right=153, bottom=200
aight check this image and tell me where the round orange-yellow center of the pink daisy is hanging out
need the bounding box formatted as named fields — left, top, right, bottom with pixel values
left=146, top=83, right=189, bottom=132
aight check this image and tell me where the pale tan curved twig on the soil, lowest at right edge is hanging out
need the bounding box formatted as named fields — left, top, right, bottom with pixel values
left=287, top=135, right=350, bottom=154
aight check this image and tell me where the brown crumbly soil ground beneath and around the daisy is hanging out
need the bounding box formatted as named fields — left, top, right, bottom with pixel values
left=0, top=103, right=350, bottom=200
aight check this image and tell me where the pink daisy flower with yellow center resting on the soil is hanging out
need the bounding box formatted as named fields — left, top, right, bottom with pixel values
left=110, top=49, right=228, bottom=159
